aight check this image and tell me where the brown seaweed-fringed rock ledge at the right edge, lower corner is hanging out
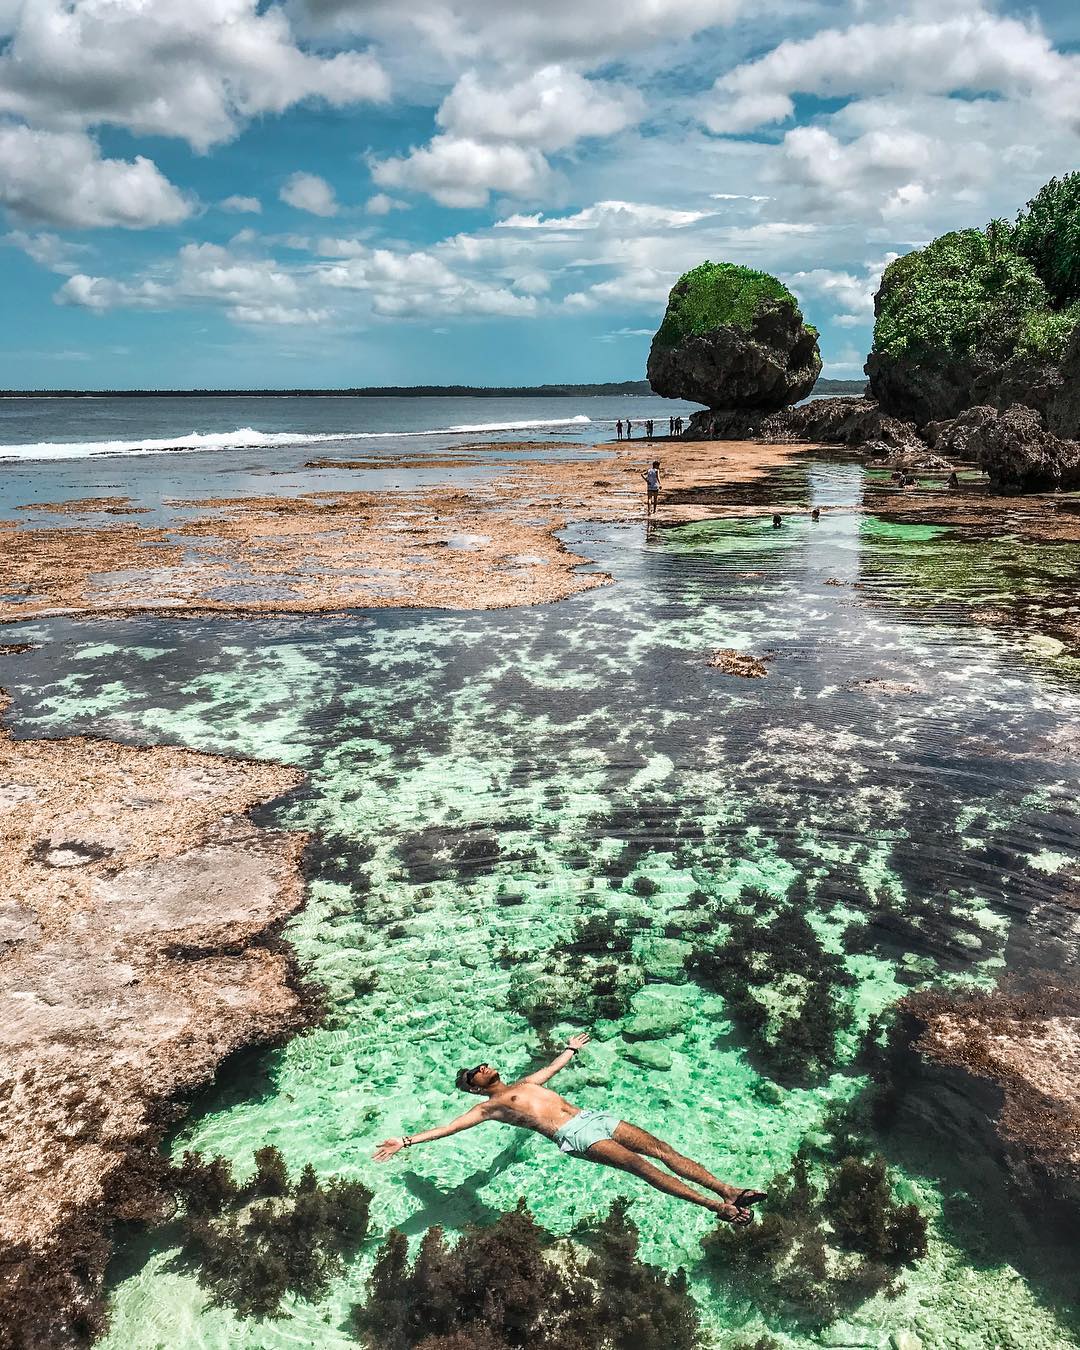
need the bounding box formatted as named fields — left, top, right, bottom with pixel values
left=902, top=984, right=1080, bottom=1188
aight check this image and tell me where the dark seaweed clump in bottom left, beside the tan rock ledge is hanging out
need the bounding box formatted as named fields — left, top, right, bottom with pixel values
left=170, top=1148, right=371, bottom=1318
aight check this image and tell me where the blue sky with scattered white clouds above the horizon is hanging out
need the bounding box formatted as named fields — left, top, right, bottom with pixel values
left=0, top=0, right=1080, bottom=387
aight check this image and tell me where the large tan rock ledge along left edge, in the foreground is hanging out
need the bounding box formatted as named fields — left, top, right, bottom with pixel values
left=0, top=693, right=312, bottom=1350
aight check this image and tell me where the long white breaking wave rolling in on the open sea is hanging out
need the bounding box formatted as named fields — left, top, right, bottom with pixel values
left=0, top=413, right=591, bottom=459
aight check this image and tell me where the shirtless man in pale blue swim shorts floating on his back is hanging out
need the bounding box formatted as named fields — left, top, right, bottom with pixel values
left=375, top=1033, right=765, bottom=1224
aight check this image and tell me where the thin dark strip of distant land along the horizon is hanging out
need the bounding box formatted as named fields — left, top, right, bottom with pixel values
left=0, top=379, right=867, bottom=398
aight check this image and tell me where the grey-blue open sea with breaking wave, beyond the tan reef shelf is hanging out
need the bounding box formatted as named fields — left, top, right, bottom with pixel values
left=0, top=397, right=697, bottom=527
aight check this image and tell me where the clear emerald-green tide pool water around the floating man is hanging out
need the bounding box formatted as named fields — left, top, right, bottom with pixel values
left=0, top=466, right=1080, bottom=1350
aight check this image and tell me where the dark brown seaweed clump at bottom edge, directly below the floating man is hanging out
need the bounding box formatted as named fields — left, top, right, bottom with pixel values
left=352, top=1202, right=699, bottom=1350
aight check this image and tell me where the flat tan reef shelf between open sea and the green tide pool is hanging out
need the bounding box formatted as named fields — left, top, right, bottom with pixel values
left=0, top=440, right=809, bottom=622
